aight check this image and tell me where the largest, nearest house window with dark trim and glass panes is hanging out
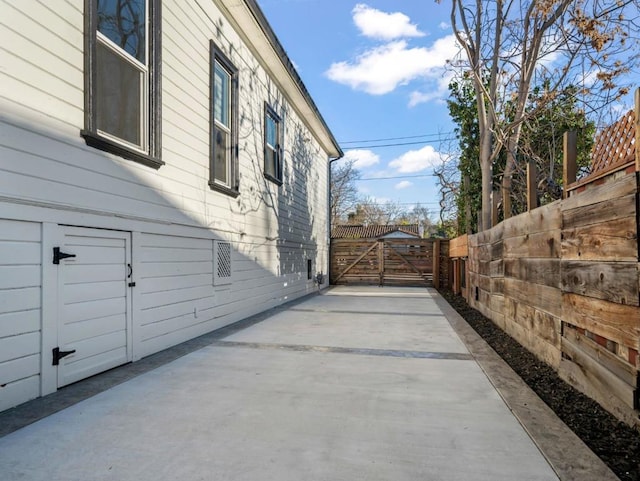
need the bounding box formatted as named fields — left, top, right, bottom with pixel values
left=81, top=0, right=164, bottom=169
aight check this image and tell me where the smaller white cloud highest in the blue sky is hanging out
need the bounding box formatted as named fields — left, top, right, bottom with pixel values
left=352, top=3, right=425, bottom=40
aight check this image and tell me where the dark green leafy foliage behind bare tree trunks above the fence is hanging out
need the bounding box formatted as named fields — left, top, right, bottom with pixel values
left=448, top=78, right=596, bottom=234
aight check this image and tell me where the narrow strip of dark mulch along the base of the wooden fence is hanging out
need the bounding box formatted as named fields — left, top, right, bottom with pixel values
left=441, top=291, right=640, bottom=481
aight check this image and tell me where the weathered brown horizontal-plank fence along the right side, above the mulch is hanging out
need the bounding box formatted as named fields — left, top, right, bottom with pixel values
left=454, top=173, right=640, bottom=424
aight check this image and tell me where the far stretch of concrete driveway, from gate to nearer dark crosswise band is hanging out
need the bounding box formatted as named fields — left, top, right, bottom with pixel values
left=227, top=287, right=468, bottom=353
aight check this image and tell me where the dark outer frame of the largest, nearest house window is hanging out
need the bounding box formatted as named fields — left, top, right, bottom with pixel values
left=80, top=0, right=164, bottom=169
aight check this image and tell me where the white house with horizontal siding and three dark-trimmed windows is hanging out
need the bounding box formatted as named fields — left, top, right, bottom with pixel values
left=0, top=0, right=342, bottom=410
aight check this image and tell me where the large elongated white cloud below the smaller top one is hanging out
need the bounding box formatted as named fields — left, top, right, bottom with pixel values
left=326, top=35, right=457, bottom=95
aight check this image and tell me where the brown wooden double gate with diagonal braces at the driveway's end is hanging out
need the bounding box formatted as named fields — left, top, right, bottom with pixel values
left=330, top=238, right=440, bottom=287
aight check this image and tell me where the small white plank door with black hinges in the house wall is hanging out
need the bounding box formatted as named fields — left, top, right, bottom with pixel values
left=52, top=227, right=132, bottom=387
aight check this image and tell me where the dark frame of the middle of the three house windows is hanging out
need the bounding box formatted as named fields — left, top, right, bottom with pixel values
left=209, top=40, right=240, bottom=197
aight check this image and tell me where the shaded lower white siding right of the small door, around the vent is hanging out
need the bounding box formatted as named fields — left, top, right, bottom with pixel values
left=134, top=234, right=322, bottom=356
